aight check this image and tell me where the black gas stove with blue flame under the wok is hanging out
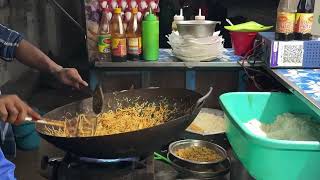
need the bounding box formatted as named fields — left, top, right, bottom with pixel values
left=40, top=153, right=155, bottom=180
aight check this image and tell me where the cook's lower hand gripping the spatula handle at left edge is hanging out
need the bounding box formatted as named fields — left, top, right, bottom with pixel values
left=0, top=95, right=41, bottom=124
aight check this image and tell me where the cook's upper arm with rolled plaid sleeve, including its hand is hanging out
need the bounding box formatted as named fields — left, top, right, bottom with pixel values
left=0, top=24, right=88, bottom=88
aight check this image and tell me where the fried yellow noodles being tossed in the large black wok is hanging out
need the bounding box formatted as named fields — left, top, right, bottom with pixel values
left=44, top=102, right=176, bottom=137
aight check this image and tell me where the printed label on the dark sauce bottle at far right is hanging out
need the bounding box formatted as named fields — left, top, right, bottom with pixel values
left=295, top=13, right=313, bottom=34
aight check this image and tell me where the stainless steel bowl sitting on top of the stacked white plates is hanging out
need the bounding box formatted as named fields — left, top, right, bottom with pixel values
left=176, top=20, right=220, bottom=38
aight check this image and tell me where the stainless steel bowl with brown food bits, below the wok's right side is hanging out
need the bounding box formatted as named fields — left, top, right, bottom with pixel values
left=169, top=139, right=228, bottom=170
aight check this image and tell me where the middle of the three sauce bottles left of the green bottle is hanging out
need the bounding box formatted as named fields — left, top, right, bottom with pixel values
left=110, top=8, right=127, bottom=62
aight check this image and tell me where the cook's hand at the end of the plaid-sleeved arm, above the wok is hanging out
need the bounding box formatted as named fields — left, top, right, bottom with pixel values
left=55, top=68, right=88, bottom=89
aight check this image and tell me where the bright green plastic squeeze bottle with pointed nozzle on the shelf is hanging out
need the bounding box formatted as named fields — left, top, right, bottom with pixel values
left=142, top=9, right=159, bottom=61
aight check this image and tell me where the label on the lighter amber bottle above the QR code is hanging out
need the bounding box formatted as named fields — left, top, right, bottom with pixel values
left=277, top=12, right=295, bottom=34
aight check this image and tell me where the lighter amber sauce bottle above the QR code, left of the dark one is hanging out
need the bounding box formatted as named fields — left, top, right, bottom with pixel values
left=275, top=0, right=297, bottom=41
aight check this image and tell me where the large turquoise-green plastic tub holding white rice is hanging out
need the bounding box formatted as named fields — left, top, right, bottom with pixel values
left=220, top=93, right=320, bottom=180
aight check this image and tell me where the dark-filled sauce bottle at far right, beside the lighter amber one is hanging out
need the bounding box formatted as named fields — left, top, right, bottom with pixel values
left=294, top=0, right=314, bottom=40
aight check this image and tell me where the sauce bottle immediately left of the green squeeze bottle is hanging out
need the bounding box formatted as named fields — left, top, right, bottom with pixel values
left=127, top=8, right=142, bottom=61
